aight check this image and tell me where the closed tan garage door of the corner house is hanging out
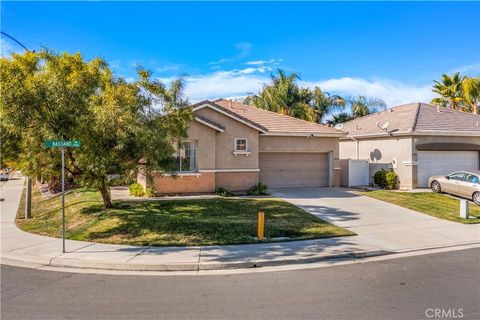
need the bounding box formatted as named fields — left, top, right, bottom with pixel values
left=259, top=152, right=328, bottom=188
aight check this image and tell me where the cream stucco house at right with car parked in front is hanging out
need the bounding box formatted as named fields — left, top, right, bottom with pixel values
left=340, top=103, right=480, bottom=189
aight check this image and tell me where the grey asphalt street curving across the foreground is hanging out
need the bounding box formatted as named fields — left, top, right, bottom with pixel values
left=1, top=249, right=480, bottom=320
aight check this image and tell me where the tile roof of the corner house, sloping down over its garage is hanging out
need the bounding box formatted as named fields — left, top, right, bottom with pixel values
left=194, top=99, right=344, bottom=135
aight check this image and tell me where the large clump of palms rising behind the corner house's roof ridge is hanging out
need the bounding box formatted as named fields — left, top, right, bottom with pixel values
left=243, top=69, right=345, bottom=123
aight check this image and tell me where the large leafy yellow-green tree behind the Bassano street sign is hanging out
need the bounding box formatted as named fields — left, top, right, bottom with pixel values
left=0, top=51, right=192, bottom=208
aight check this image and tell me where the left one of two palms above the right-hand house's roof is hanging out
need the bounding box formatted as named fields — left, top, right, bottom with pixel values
left=432, top=72, right=463, bottom=110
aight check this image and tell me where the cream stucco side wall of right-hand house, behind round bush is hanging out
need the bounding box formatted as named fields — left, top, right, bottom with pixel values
left=340, top=137, right=416, bottom=189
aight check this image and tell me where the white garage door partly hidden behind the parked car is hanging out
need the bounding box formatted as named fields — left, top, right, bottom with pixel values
left=417, top=151, right=478, bottom=187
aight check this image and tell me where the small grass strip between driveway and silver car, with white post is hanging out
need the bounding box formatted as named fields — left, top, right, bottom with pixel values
left=358, top=190, right=480, bottom=223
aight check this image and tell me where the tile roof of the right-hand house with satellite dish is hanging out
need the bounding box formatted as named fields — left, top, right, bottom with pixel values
left=343, top=103, right=480, bottom=137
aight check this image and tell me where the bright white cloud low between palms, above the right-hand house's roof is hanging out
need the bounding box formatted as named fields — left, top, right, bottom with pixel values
left=300, top=77, right=435, bottom=107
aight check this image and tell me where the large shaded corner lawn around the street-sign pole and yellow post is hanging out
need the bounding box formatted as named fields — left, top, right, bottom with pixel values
left=17, top=189, right=353, bottom=246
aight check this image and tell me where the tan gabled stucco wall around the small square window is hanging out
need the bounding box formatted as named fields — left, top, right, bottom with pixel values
left=196, top=108, right=258, bottom=169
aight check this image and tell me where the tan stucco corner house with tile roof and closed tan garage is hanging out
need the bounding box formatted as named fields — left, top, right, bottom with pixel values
left=138, top=99, right=345, bottom=194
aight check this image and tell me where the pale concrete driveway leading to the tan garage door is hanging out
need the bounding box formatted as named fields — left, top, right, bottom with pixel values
left=272, top=188, right=480, bottom=252
